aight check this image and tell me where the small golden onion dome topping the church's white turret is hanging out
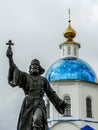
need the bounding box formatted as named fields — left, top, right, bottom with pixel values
left=64, top=19, right=76, bottom=41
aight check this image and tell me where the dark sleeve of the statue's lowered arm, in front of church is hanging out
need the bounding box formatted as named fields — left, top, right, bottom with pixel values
left=45, top=80, right=65, bottom=114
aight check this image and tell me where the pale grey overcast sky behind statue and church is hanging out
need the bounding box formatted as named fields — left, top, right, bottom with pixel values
left=0, top=0, right=98, bottom=130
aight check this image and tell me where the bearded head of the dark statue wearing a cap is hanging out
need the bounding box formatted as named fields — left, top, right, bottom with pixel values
left=29, top=59, right=45, bottom=75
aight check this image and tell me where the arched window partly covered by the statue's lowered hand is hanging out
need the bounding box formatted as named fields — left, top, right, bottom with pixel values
left=63, top=95, right=71, bottom=116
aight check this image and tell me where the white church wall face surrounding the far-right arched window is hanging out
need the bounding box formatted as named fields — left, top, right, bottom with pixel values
left=79, top=82, right=98, bottom=120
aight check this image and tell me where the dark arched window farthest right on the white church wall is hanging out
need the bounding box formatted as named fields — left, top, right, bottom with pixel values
left=86, top=97, right=92, bottom=118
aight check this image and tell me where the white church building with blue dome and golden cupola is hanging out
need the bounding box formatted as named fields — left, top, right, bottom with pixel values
left=46, top=14, right=98, bottom=130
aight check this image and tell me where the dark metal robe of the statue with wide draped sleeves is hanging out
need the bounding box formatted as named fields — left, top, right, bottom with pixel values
left=8, top=66, right=64, bottom=130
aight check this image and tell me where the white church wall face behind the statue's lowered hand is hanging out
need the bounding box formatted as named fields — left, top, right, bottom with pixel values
left=49, top=82, right=79, bottom=119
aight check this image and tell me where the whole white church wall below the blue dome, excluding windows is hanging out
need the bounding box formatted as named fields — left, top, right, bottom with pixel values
left=51, top=81, right=98, bottom=130
